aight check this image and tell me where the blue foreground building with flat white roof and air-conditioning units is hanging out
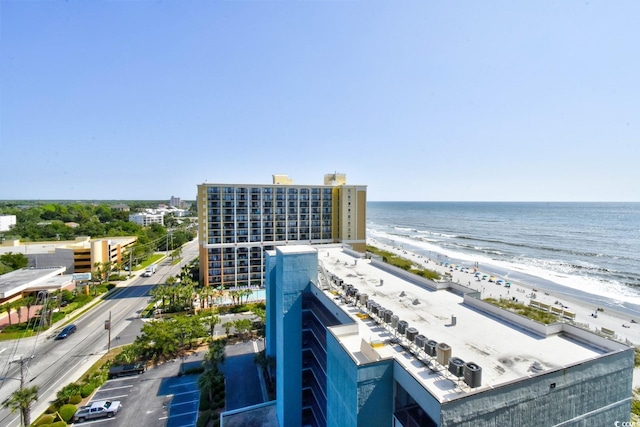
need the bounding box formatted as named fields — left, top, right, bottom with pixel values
left=226, top=245, right=634, bottom=427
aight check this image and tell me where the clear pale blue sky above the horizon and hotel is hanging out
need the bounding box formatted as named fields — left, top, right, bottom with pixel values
left=0, top=0, right=640, bottom=201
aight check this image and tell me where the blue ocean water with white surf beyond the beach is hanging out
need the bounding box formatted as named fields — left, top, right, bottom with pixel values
left=367, top=202, right=640, bottom=316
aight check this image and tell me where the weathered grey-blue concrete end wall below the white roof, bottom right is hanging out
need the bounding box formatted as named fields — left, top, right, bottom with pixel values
left=440, top=349, right=634, bottom=427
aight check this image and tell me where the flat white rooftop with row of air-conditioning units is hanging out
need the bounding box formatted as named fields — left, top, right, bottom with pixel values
left=318, top=247, right=619, bottom=402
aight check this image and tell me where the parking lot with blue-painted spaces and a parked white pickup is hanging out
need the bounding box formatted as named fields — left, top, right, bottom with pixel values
left=75, top=355, right=202, bottom=427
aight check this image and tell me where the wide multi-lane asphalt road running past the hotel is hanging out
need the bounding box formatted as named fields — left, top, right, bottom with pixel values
left=0, top=240, right=198, bottom=427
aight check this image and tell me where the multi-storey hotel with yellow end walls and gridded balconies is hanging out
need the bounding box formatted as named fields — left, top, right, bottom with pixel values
left=198, top=173, right=367, bottom=287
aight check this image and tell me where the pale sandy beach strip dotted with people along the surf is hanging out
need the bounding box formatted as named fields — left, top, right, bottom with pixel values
left=367, top=238, right=640, bottom=388
